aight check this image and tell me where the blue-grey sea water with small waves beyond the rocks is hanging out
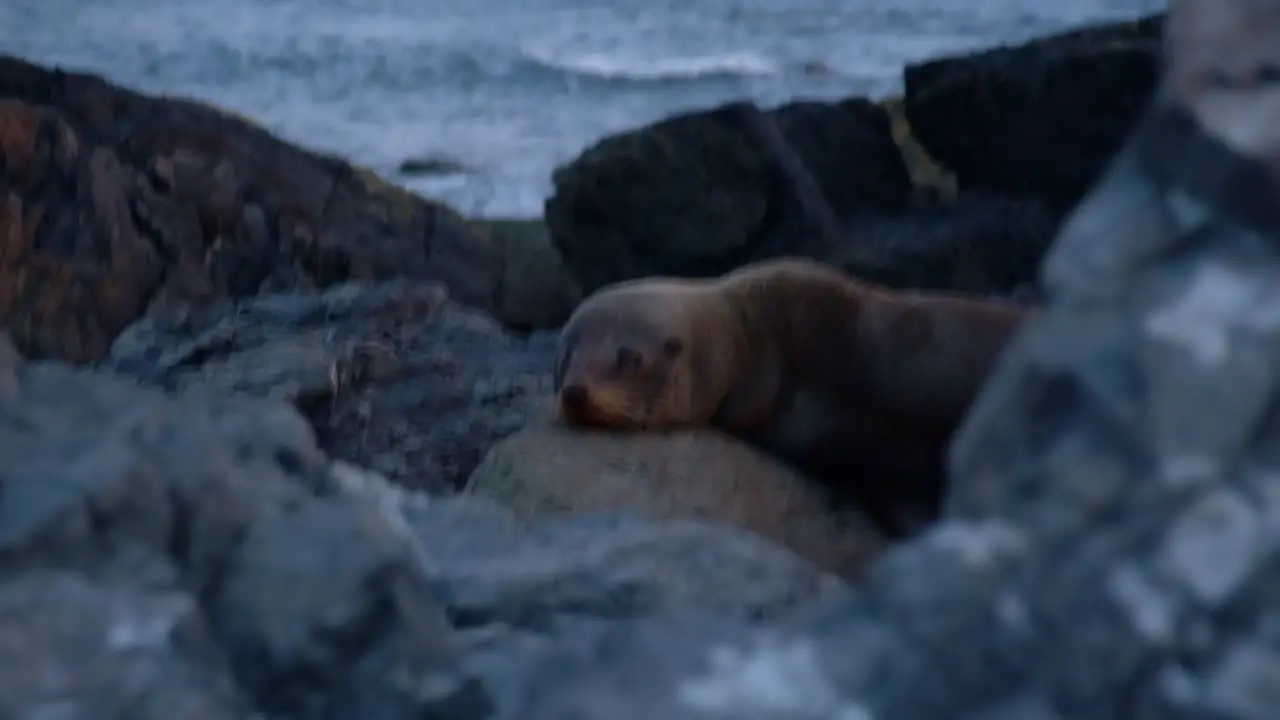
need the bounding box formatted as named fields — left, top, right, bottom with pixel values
left=0, top=0, right=1165, bottom=215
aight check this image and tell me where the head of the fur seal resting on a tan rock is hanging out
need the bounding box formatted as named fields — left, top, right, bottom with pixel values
left=556, top=279, right=717, bottom=430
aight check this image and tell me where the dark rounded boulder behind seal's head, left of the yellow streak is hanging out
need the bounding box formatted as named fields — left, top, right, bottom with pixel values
left=545, top=99, right=913, bottom=292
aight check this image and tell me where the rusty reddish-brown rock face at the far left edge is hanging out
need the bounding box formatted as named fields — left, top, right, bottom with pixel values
left=0, top=100, right=165, bottom=363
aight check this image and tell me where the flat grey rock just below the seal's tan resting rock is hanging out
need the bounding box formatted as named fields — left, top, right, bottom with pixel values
left=410, top=498, right=845, bottom=629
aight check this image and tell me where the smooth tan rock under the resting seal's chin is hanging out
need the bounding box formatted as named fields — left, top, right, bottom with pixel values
left=466, top=420, right=886, bottom=578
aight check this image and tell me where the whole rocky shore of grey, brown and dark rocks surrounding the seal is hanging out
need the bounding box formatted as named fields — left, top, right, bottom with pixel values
left=0, top=7, right=1280, bottom=720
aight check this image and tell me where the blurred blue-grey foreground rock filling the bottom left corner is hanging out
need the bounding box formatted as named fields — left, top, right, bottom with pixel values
left=0, top=570, right=252, bottom=720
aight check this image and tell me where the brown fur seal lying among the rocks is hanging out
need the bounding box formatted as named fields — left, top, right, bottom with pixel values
left=554, top=258, right=1029, bottom=537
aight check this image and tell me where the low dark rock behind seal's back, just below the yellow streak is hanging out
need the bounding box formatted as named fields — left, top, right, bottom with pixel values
left=829, top=196, right=1057, bottom=296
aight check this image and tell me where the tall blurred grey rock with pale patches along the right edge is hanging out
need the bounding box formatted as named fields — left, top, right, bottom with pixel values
left=950, top=8, right=1280, bottom=527
